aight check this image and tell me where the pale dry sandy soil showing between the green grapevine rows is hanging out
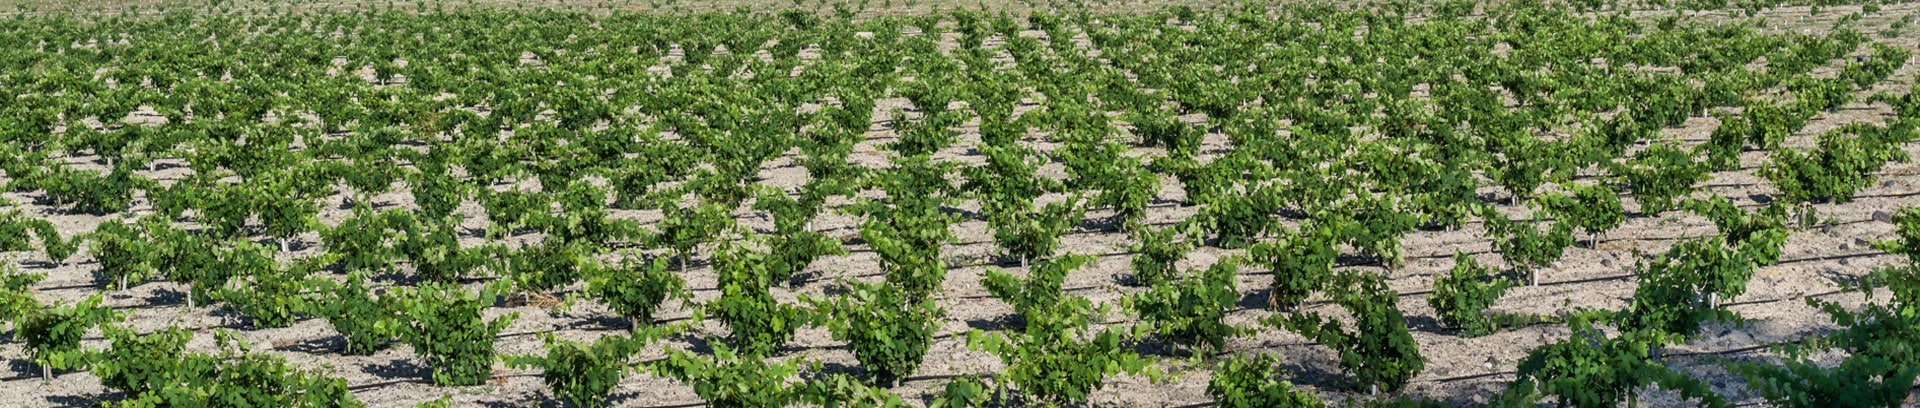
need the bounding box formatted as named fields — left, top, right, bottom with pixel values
left=0, top=0, right=1920, bottom=406
